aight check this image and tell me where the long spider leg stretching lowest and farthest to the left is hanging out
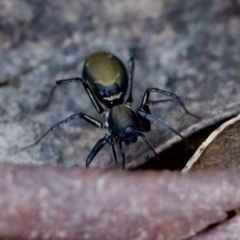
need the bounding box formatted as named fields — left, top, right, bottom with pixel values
left=21, top=113, right=104, bottom=151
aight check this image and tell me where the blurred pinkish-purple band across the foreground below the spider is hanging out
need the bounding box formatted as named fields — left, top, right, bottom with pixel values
left=0, top=164, right=240, bottom=239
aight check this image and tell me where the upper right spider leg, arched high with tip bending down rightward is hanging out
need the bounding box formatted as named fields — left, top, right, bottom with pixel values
left=140, top=88, right=200, bottom=119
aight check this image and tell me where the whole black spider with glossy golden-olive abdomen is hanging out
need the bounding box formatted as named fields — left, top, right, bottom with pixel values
left=22, top=52, right=197, bottom=169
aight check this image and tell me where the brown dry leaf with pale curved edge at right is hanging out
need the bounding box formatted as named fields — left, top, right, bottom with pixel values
left=183, top=115, right=240, bottom=172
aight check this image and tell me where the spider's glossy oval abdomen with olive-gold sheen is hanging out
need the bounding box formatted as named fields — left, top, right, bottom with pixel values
left=83, top=52, right=128, bottom=108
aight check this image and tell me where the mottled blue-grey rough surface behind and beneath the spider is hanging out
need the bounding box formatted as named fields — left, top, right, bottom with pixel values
left=0, top=0, right=240, bottom=167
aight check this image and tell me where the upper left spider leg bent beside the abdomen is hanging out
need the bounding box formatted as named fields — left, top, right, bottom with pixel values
left=41, top=77, right=104, bottom=114
